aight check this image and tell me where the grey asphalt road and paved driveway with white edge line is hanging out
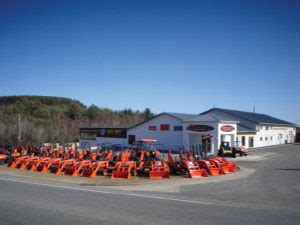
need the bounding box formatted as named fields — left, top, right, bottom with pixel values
left=0, top=145, right=300, bottom=225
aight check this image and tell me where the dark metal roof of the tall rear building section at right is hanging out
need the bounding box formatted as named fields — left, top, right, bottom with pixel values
left=201, top=108, right=295, bottom=126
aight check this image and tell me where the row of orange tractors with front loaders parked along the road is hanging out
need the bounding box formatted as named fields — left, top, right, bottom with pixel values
left=1, top=143, right=238, bottom=179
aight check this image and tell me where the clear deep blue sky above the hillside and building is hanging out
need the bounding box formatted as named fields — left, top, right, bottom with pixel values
left=0, top=0, right=300, bottom=124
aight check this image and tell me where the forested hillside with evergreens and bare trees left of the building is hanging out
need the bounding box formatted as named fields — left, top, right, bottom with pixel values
left=0, top=96, right=153, bottom=145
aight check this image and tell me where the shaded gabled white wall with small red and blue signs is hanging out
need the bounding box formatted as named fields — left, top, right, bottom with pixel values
left=127, top=114, right=183, bottom=150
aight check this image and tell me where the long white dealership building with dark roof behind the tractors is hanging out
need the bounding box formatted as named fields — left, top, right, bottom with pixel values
left=80, top=108, right=296, bottom=154
